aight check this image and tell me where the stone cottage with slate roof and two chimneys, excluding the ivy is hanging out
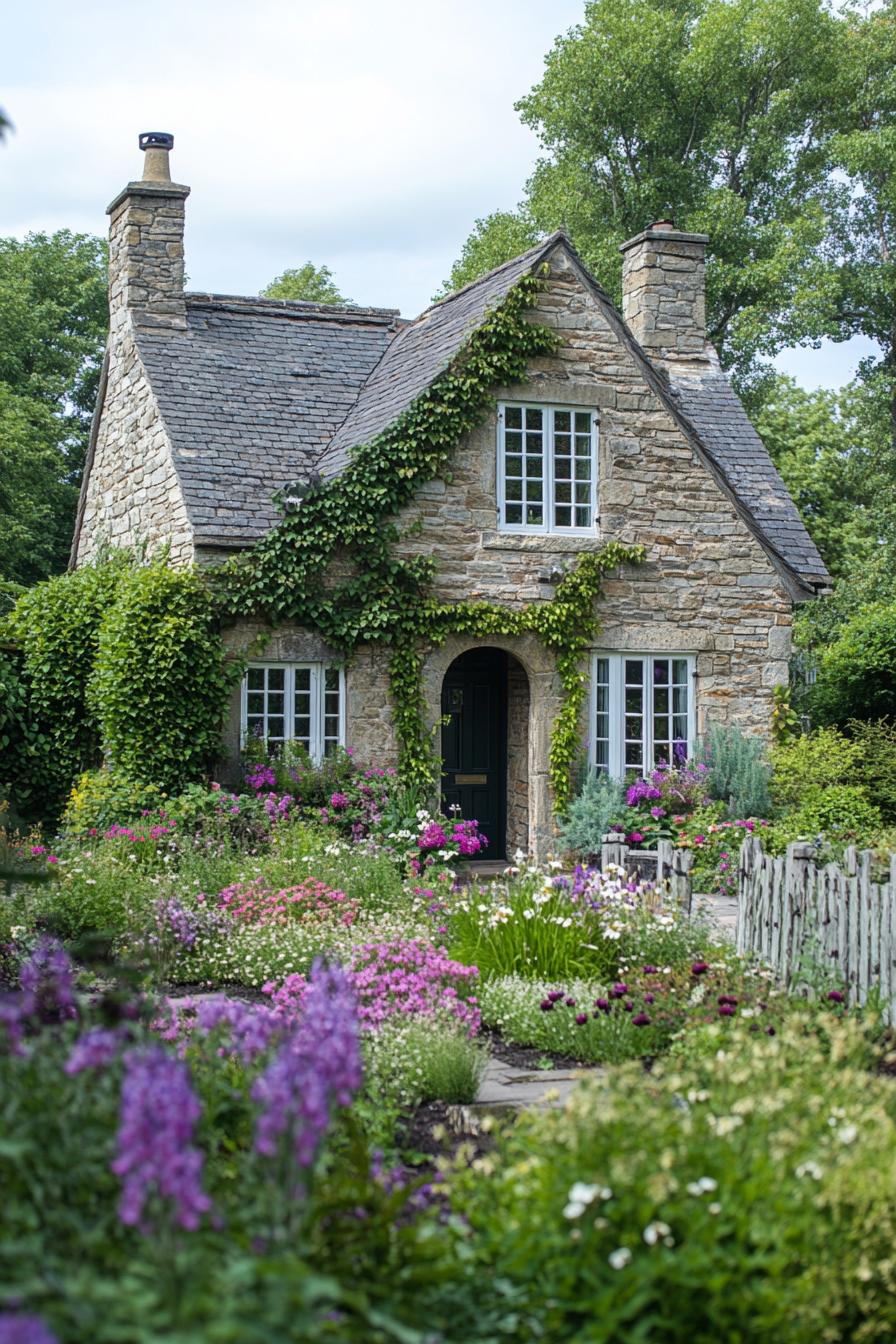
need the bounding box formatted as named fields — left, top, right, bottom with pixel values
left=73, top=134, right=829, bottom=857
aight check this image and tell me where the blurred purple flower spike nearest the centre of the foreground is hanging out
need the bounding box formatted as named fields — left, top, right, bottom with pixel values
left=253, top=960, right=363, bottom=1168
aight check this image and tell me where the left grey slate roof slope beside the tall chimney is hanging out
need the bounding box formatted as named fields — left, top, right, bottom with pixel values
left=137, top=294, right=400, bottom=547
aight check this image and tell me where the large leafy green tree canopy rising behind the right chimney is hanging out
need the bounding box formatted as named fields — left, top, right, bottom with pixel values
left=447, top=0, right=896, bottom=408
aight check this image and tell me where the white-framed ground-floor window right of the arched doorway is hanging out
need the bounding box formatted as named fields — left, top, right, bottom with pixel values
left=590, top=652, right=696, bottom=780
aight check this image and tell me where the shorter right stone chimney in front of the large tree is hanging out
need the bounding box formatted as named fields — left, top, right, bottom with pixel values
left=619, top=219, right=709, bottom=359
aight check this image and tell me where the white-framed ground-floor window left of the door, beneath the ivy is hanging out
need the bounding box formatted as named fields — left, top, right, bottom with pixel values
left=240, top=663, right=345, bottom=763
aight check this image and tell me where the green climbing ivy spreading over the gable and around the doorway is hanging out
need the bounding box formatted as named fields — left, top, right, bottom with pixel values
left=217, top=276, right=643, bottom=810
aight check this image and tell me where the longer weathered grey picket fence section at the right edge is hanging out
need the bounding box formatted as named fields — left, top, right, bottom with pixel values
left=737, top=836, right=896, bottom=1023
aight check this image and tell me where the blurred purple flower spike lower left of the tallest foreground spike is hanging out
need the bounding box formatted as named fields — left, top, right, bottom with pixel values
left=111, top=1046, right=211, bottom=1232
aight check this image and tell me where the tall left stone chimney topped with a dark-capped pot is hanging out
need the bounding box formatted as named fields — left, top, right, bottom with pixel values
left=106, top=130, right=189, bottom=333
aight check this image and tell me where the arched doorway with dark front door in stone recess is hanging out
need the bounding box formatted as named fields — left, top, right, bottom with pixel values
left=442, top=648, right=529, bottom=859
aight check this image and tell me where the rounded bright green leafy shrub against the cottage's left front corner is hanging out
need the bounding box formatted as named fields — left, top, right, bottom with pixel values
left=92, top=563, right=235, bottom=793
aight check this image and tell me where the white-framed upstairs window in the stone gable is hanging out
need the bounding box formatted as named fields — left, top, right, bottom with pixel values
left=498, top=403, right=598, bottom=532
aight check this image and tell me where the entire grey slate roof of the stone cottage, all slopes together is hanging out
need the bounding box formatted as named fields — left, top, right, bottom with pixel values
left=108, top=233, right=830, bottom=589
